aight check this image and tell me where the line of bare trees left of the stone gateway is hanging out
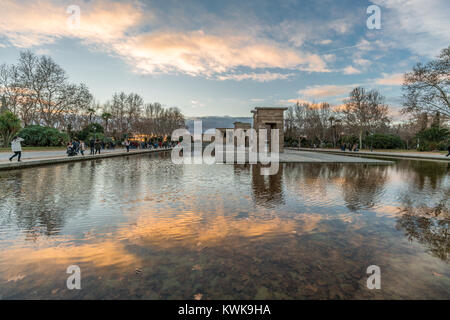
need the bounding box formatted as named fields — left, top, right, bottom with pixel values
left=0, top=51, right=185, bottom=146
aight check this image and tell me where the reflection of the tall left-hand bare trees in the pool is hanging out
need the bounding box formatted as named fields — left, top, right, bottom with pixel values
left=0, top=160, right=97, bottom=241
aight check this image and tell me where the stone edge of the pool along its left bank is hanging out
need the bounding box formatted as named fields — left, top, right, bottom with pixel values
left=0, top=148, right=172, bottom=171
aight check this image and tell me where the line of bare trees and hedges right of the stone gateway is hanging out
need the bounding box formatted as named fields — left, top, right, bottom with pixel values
left=285, top=47, right=450, bottom=150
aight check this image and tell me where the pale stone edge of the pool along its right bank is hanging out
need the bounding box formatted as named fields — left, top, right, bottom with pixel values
left=285, top=147, right=450, bottom=162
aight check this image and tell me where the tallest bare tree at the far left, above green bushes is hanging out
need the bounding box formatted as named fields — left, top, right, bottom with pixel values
left=0, top=51, right=93, bottom=127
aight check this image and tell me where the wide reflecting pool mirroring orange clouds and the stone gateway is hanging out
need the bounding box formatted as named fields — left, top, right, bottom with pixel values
left=0, top=153, right=450, bottom=299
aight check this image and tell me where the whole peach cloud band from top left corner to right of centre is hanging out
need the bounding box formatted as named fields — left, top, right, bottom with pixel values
left=0, top=0, right=329, bottom=81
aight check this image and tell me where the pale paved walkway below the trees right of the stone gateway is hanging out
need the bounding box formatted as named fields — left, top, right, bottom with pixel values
left=285, top=148, right=450, bottom=161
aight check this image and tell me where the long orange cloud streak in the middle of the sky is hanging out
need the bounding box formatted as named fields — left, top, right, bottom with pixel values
left=116, top=30, right=327, bottom=76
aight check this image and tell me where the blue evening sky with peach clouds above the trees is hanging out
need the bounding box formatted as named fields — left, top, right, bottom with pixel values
left=0, top=0, right=450, bottom=118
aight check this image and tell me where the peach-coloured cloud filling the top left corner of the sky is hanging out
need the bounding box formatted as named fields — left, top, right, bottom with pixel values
left=0, top=0, right=143, bottom=48
